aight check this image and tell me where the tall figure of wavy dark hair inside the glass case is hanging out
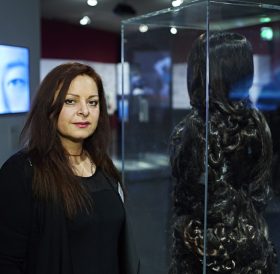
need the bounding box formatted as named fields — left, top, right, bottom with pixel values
left=170, top=32, right=276, bottom=274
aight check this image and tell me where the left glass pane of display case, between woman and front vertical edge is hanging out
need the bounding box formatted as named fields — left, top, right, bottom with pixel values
left=119, top=1, right=208, bottom=274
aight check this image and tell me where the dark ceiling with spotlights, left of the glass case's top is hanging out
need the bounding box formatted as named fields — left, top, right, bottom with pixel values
left=41, top=0, right=171, bottom=32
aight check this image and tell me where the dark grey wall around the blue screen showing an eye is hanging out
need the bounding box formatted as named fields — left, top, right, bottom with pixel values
left=0, top=0, right=40, bottom=166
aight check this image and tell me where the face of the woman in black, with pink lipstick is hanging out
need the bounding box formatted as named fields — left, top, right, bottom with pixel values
left=57, top=75, right=100, bottom=147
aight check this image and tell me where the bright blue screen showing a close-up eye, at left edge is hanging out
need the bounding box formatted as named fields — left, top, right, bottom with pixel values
left=0, top=45, right=30, bottom=114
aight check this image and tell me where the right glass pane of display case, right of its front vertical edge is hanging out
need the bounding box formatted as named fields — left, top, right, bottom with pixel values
left=206, top=1, right=280, bottom=274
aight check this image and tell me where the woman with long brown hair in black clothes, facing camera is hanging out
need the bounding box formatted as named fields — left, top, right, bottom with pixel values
left=0, top=63, right=139, bottom=274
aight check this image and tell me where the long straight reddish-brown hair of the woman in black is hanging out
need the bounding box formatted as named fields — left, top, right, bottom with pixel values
left=21, top=63, right=120, bottom=217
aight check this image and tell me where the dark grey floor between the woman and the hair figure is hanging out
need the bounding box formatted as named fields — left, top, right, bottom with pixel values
left=127, top=176, right=171, bottom=274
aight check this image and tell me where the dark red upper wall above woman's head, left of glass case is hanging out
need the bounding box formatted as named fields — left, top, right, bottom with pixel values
left=41, top=19, right=120, bottom=63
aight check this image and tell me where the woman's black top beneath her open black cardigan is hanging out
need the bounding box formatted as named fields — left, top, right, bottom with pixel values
left=67, top=169, right=125, bottom=274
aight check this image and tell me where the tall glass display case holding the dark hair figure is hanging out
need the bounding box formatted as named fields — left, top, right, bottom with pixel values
left=121, top=0, right=280, bottom=274
